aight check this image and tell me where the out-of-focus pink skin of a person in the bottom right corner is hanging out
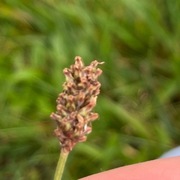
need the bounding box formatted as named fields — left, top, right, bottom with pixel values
left=80, top=156, right=180, bottom=180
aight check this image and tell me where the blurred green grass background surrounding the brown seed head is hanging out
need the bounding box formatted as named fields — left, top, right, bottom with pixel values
left=0, top=0, right=180, bottom=180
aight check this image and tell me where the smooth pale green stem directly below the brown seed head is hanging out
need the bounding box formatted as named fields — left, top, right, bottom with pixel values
left=54, top=151, right=69, bottom=180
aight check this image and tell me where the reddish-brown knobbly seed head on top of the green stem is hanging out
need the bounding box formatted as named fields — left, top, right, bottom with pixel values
left=51, top=56, right=103, bottom=152
